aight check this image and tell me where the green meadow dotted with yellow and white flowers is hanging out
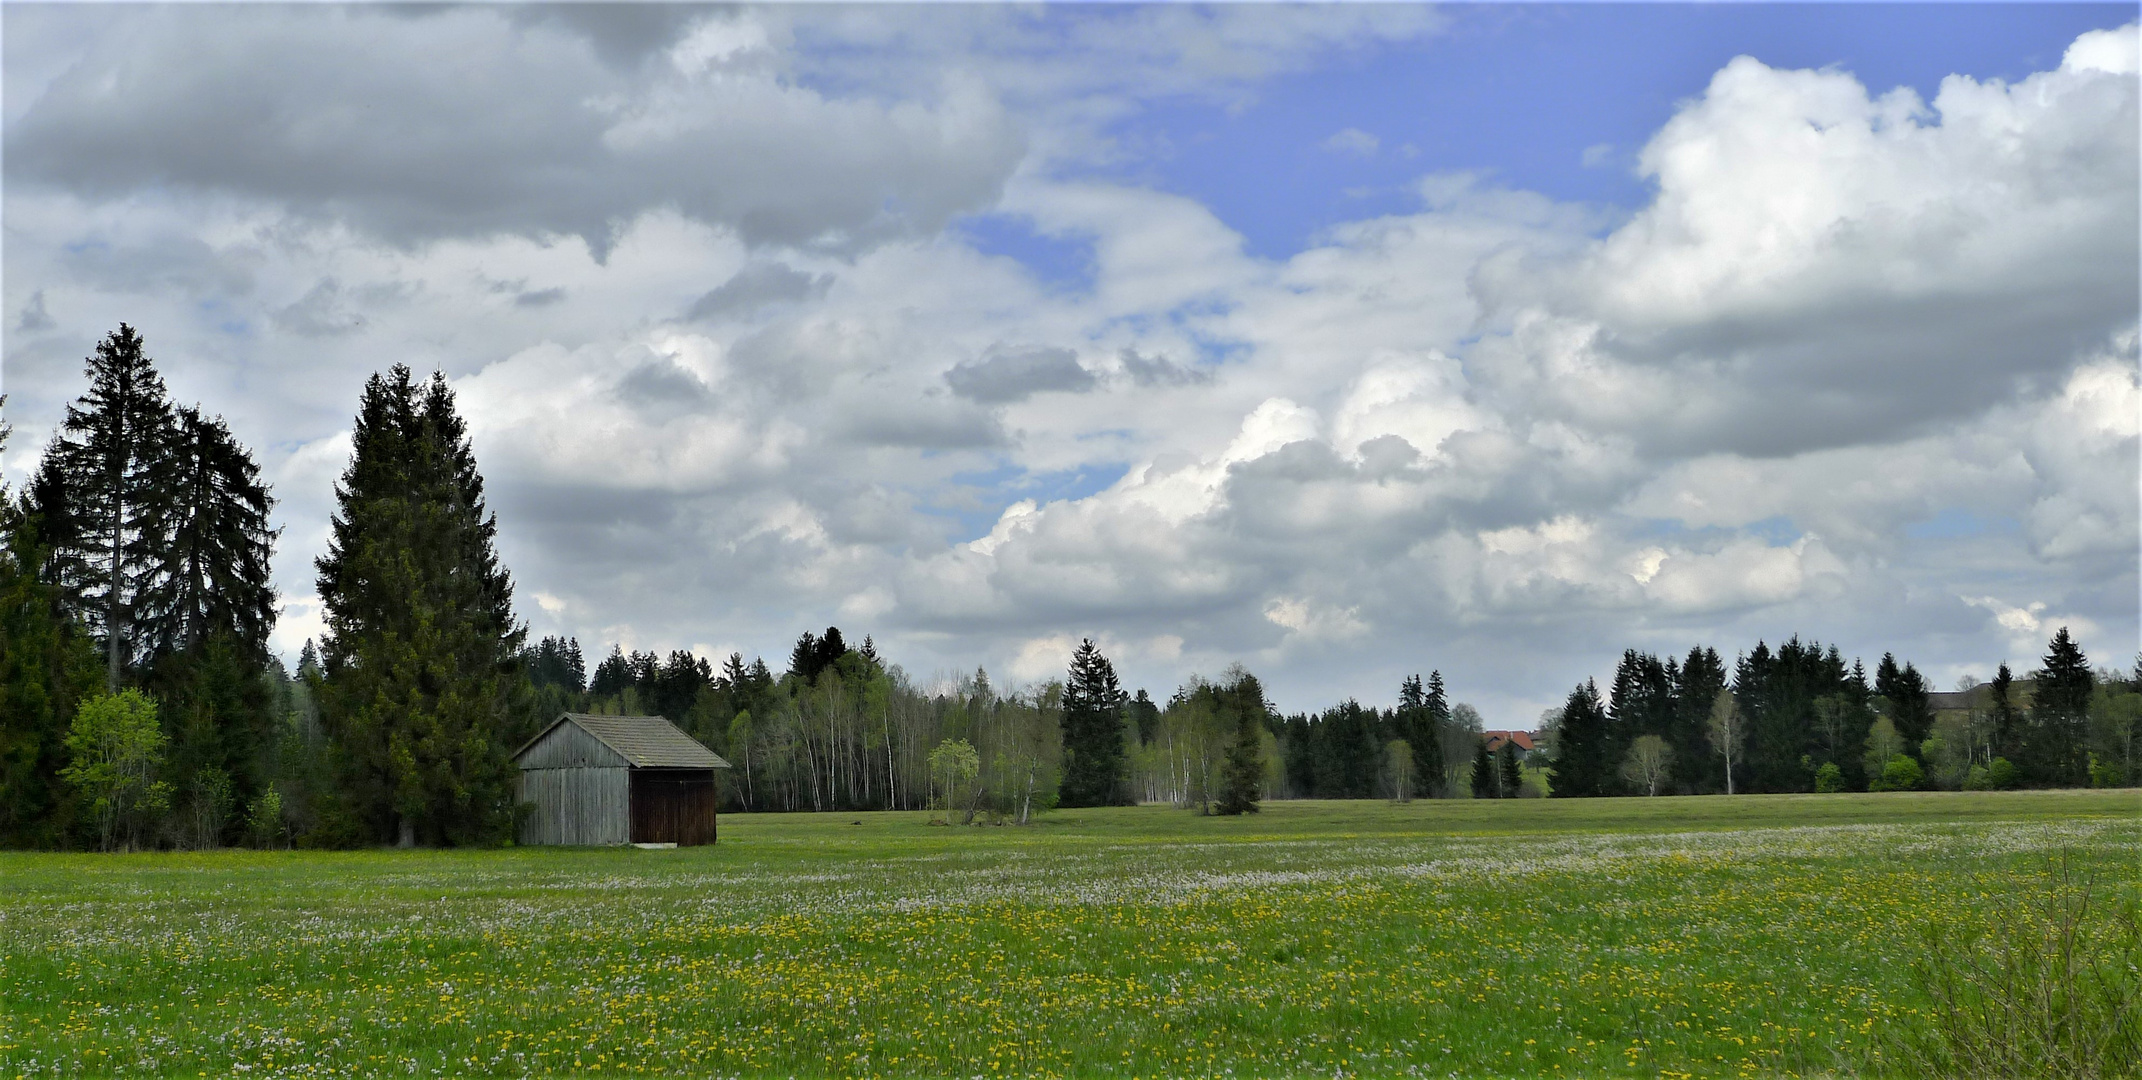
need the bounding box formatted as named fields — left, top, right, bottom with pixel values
left=0, top=791, right=2142, bottom=1076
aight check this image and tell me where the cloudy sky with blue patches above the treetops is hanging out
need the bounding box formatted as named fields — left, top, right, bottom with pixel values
left=0, top=2, right=2142, bottom=726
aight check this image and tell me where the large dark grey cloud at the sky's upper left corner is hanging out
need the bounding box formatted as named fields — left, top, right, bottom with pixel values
left=6, top=4, right=1024, bottom=257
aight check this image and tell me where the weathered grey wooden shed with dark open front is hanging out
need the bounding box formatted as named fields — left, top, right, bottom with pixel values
left=514, top=714, right=728, bottom=846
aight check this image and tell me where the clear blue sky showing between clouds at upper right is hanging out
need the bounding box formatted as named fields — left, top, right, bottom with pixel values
left=964, top=4, right=2138, bottom=287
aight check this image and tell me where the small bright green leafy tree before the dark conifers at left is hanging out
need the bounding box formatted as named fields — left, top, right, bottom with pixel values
left=60, top=690, right=171, bottom=851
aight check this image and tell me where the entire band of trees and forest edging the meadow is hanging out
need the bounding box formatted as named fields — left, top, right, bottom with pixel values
left=0, top=326, right=2142, bottom=851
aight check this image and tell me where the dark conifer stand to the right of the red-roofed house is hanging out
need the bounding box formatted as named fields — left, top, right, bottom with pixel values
left=1547, top=626, right=2142, bottom=795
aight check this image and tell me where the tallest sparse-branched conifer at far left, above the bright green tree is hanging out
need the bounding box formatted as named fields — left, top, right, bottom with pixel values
left=36, top=324, right=171, bottom=692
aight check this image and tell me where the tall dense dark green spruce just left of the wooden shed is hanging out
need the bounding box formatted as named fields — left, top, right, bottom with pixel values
left=317, top=364, right=533, bottom=844
